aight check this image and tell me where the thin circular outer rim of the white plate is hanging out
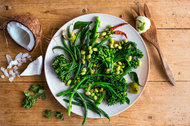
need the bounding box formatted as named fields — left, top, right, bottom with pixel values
left=43, top=13, right=150, bottom=118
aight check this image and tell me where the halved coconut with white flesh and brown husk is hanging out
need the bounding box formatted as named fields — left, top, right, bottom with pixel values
left=7, top=14, right=42, bottom=51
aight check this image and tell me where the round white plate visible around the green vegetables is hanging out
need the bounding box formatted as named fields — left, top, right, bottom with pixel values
left=44, top=14, right=149, bottom=118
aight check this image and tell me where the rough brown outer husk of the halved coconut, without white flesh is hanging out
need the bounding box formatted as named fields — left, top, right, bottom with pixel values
left=7, top=13, right=42, bottom=51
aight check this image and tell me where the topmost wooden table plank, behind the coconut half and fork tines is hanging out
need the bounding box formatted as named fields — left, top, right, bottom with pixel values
left=0, top=0, right=190, bottom=29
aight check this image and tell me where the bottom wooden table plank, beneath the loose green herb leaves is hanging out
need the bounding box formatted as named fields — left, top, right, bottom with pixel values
left=0, top=82, right=190, bottom=126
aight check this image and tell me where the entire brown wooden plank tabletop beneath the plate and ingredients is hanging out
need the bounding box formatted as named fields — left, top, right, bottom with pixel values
left=0, top=0, right=190, bottom=126
